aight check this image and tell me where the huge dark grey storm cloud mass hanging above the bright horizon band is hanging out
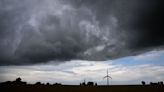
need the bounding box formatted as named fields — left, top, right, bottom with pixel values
left=0, top=0, right=164, bottom=65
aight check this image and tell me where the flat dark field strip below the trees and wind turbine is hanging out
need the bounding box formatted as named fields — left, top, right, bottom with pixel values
left=0, top=85, right=164, bottom=92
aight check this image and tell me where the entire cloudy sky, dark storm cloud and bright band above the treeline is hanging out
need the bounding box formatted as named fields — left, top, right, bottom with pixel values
left=0, top=0, right=164, bottom=84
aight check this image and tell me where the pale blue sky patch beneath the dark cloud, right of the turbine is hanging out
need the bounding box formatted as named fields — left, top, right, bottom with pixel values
left=113, top=51, right=164, bottom=66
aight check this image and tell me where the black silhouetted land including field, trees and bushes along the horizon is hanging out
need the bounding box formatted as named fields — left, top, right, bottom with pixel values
left=0, top=78, right=164, bottom=92
